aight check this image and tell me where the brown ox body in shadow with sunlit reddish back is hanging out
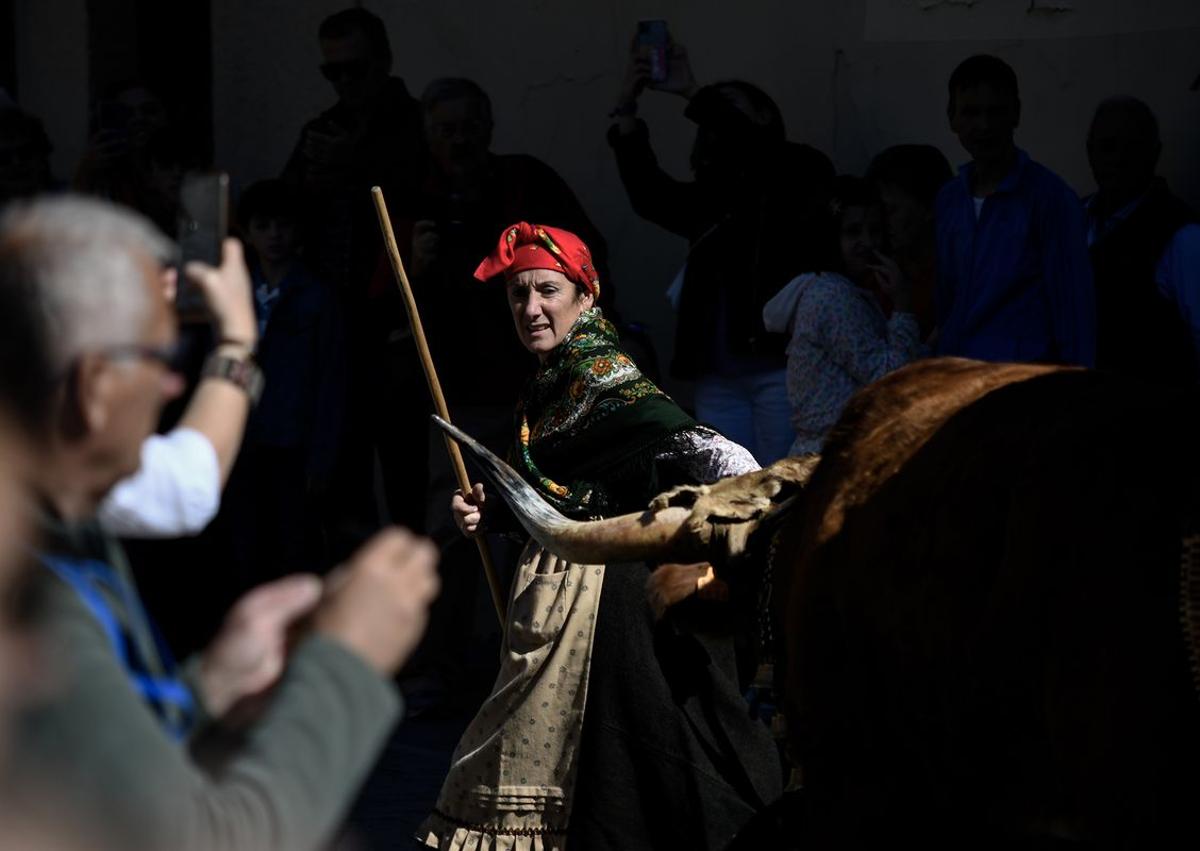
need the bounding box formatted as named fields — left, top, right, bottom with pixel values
left=775, top=360, right=1200, bottom=847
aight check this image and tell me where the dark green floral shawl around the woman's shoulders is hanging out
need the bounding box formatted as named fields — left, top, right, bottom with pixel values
left=512, top=307, right=696, bottom=519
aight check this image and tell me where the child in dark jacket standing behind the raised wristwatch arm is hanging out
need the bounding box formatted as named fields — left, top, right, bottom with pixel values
left=225, top=180, right=347, bottom=581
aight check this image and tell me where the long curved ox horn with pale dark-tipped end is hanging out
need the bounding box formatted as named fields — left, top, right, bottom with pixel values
left=433, top=414, right=704, bottom=564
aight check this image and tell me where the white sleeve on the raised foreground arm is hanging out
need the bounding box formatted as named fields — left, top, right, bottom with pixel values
left=98, top=429, right=221, bottom=538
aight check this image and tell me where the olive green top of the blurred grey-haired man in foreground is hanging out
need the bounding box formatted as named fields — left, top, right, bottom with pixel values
left=17, top=577, right=401, bottom=851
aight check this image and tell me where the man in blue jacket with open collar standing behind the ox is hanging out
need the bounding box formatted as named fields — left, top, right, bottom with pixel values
left=936, top=55, right=1096, bottom=366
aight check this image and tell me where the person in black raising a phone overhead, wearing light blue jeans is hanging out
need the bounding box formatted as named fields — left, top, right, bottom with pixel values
left=608, top=22, right=833, bottom=465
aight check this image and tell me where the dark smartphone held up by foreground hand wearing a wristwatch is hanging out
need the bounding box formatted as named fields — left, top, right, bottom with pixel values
left=175, top=172, right=229, bottom=320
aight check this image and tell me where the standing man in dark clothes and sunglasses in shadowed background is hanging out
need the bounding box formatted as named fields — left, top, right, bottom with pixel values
left=281, top=8, right=427, bottom=544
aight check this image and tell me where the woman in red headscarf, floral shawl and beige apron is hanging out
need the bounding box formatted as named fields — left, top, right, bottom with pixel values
left=419, top=222, right=781, bottom=851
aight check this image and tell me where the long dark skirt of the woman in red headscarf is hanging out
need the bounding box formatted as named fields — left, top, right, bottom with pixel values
left=568, top=564, right=782, bottom=851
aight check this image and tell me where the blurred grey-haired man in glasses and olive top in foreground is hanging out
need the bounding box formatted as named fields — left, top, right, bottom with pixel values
left=0, top=196, right=438, bottom=851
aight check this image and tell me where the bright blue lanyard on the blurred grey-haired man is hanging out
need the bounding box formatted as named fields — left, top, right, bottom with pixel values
left=38, top=553, right=196, bottom=739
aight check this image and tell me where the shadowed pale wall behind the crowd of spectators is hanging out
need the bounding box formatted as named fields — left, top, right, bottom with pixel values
left=204, top=0, right=1200, bottom=396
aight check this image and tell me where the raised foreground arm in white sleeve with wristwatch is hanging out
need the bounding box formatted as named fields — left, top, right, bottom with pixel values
left=100, top=239, right=260, bottom=538
